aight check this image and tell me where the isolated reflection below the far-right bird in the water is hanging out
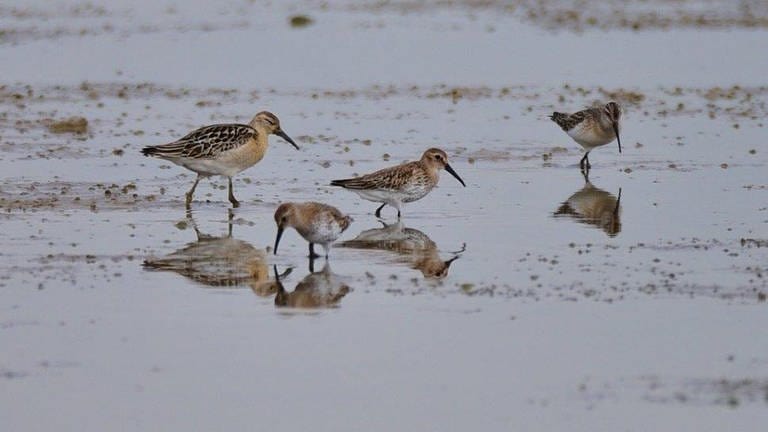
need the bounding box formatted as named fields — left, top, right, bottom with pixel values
left=554, top=175, right=621, bottom=237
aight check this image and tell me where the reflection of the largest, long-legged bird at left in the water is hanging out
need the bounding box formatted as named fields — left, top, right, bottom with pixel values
left=144, top=209, right=277, bottom=296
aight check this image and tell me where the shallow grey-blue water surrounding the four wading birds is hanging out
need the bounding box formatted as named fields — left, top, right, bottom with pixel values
left=0, top=2, right=768, bottom=431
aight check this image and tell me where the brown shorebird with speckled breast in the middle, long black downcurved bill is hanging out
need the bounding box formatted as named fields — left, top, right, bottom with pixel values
left=331, top=148, right=467, bottom=218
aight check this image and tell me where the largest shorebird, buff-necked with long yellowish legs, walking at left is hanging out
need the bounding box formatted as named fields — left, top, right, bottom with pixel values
left=141, top=111, right=299, bottom=208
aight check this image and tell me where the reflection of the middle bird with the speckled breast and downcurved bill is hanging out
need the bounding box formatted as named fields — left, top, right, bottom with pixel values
left=340, top=221, right=466, bottom=279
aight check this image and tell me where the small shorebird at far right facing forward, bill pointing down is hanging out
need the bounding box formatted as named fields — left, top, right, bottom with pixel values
left=549, top=102, right=621, bottom=170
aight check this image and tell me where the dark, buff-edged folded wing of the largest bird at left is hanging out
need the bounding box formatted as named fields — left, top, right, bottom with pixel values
left=141, top=124, right=258, bottom=159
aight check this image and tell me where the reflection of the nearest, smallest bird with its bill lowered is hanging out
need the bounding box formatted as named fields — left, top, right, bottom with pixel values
left=273, top=261, right=350, bottom=309
